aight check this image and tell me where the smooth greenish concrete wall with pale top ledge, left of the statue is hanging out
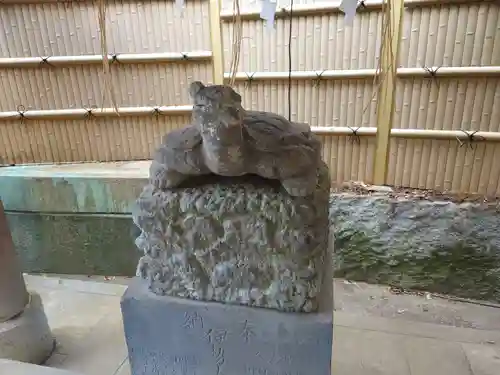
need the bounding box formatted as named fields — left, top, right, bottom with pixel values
left=0, top=161, right=149, bottom=276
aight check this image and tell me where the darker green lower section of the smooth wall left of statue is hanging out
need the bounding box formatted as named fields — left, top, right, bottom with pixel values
left=7, top=212, right=141, bottom=276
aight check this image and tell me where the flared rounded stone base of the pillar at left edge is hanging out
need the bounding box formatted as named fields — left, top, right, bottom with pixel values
left=0, top=293, right=55, bottom=364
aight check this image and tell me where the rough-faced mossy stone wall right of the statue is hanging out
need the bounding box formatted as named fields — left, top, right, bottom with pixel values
left=330, top=194, right=500, bottom=302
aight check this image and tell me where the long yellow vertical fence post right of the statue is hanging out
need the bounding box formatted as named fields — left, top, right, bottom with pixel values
left=373, top=0, right=404, bottom=185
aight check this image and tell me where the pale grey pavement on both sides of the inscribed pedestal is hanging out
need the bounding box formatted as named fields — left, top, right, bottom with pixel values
left=25, top=275, right=500, bottom=375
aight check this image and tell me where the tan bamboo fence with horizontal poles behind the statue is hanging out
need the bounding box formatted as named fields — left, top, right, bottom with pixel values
left=0, top=0, right=500, bottom=195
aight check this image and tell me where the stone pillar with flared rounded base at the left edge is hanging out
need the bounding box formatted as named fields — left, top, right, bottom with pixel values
left=0, top=201, right=54, bottom=363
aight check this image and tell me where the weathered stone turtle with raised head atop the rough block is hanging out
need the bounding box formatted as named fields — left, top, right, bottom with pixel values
left=150, top=82, right=321, bottom=196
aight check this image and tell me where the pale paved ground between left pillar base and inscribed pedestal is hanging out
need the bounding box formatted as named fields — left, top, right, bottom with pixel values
left=24, top=275, right=127, bottom=375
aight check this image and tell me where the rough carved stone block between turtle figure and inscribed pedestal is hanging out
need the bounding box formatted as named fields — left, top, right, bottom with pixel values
left=134, top=165, right=330, bottom=312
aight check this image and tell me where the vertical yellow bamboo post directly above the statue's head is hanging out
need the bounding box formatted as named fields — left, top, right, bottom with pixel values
left=209, top=0, right=224, bottom=85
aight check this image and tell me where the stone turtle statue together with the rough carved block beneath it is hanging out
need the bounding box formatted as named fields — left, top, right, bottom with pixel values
left=133, top=82, right=331, bottom=312
